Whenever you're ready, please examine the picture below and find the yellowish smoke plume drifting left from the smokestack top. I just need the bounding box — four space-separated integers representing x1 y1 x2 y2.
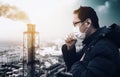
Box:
0 4 30 23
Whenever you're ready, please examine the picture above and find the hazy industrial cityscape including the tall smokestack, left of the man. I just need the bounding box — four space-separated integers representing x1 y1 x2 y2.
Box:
0 24 71 77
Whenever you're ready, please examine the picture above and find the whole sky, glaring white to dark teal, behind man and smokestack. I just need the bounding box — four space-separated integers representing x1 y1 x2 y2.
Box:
0 0 120 40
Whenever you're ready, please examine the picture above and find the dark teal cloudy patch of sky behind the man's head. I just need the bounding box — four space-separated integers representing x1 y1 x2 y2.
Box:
80 0 120 26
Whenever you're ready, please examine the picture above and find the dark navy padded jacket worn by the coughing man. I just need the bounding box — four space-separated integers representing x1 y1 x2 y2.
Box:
62 28 120 77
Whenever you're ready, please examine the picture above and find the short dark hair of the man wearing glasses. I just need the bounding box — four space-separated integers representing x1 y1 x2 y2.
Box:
74 6 99 29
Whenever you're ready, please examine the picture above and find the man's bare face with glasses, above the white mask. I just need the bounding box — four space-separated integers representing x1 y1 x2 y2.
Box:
73 14 87 33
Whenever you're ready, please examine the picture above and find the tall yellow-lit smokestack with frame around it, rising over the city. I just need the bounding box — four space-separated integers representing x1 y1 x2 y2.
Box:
23 24 39 77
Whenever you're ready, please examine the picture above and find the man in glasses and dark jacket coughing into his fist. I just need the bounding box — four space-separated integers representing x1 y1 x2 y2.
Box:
62 6 120 77
